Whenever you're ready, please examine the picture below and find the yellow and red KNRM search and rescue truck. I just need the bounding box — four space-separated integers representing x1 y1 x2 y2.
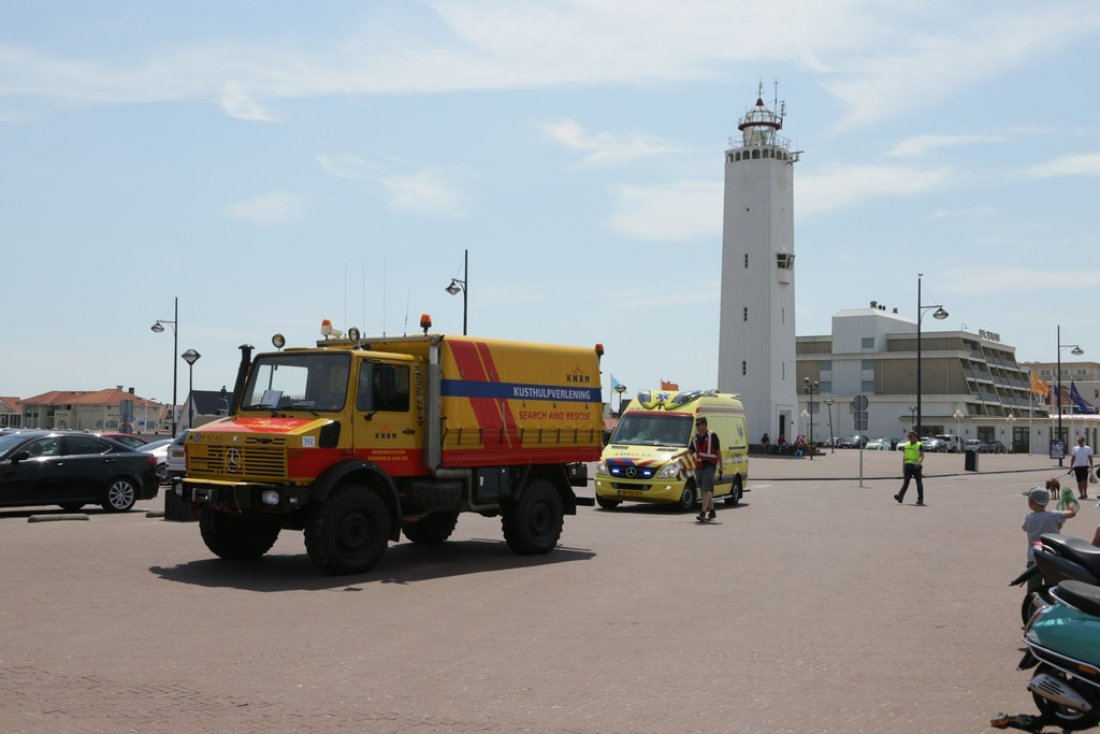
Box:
180 316 603 573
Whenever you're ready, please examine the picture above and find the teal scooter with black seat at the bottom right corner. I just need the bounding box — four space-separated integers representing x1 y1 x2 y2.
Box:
1019 580 1100 732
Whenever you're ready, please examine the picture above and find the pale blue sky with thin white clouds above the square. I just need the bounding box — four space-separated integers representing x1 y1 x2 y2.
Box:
0 0 1100 403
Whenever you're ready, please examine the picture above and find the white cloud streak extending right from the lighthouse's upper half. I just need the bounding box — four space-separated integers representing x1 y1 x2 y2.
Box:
794 166 952 218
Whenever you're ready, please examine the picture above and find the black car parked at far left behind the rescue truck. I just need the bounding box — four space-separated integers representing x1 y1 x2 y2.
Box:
0 430 157 512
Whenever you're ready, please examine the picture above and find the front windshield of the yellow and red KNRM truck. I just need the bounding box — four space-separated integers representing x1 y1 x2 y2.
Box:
241 352 351 410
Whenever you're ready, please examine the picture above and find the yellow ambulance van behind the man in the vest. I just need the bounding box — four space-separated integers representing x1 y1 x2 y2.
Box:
595 390 749 511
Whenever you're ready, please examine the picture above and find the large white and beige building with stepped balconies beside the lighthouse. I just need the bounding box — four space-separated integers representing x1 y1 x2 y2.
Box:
796 302 1100 453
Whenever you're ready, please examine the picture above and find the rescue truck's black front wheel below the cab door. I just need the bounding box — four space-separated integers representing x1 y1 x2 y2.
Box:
306 484 389 573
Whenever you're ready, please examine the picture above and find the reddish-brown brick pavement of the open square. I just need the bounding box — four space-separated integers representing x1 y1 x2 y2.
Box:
0 451 1082 734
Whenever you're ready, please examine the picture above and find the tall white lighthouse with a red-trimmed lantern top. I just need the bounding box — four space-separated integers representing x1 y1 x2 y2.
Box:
718 87 802 445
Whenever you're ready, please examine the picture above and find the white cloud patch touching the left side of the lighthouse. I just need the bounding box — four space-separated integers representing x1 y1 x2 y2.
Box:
612 180 723 241
